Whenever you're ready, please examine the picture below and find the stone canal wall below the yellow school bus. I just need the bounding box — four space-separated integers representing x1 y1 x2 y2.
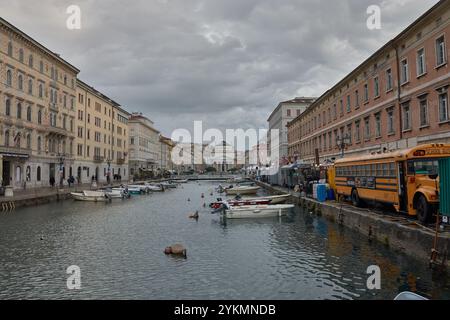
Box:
256 181 450 269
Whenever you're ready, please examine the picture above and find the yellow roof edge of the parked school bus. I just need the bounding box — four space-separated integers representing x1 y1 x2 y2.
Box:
335 144 450 165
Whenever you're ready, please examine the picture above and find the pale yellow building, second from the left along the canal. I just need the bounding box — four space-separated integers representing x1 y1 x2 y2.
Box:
74 80 130 183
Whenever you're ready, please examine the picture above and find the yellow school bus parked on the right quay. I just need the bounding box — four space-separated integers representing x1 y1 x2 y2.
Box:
335 144 450 223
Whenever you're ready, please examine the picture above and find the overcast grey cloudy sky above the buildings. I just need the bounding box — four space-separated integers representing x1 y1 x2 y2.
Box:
0 0 437 136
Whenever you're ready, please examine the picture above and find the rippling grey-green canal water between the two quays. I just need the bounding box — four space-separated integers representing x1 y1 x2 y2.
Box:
0 182 450 299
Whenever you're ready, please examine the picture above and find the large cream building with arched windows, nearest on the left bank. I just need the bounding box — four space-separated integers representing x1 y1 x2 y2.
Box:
0 18 79 188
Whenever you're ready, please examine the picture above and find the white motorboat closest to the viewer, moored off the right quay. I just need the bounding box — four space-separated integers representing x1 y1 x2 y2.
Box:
224 204 294 219
